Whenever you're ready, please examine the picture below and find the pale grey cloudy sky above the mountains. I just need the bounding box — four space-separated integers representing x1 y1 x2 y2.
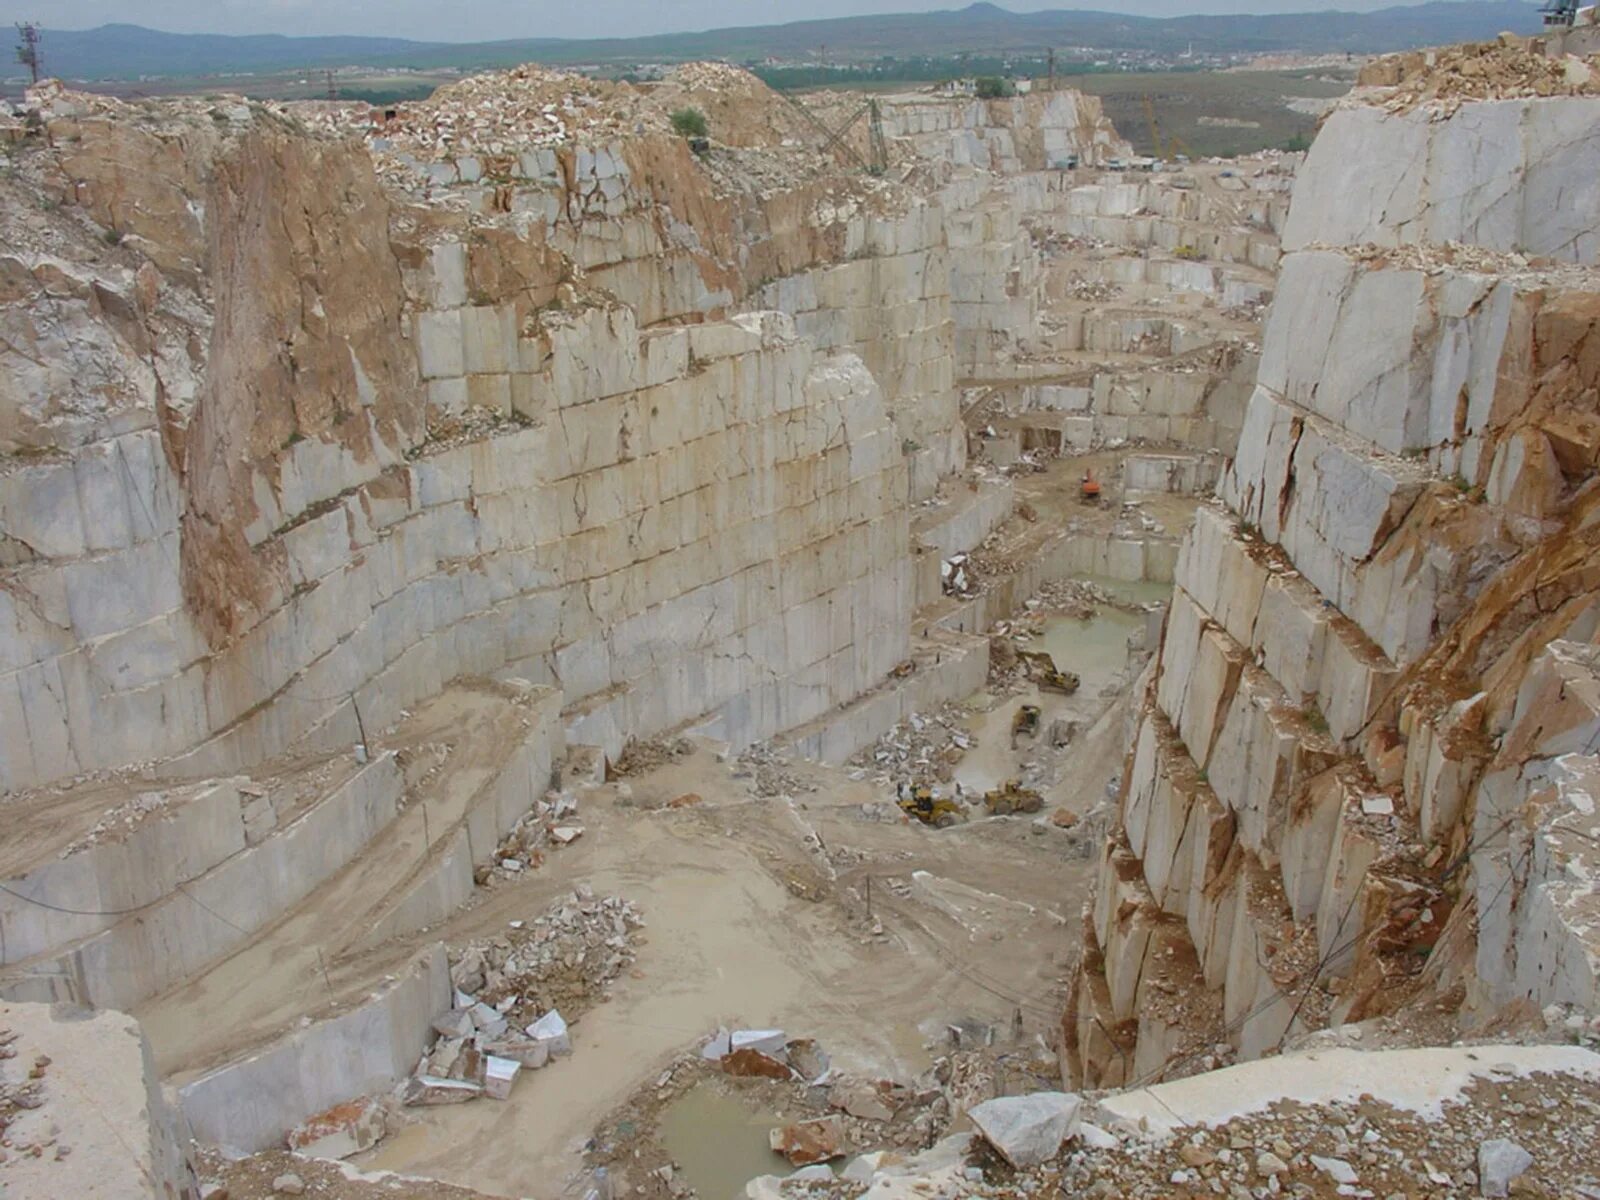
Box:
0 0 1478 42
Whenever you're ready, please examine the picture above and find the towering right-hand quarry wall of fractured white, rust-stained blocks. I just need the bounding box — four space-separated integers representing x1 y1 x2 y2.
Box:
1064 99 1600 1085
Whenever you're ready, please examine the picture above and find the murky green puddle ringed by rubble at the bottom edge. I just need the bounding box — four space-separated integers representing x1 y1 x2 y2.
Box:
661 1083 794 1200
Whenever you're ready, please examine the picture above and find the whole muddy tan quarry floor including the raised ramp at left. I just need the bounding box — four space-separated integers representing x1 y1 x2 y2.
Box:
138 454 1194 1200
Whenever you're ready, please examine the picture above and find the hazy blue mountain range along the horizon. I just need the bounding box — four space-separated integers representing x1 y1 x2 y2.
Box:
12 0 1539 80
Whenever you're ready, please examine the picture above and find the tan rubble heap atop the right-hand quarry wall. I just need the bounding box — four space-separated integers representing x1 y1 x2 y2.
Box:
1357 34 1600 114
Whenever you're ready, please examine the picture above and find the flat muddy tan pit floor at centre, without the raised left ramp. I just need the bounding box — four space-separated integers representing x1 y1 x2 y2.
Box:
342 672 1122 1197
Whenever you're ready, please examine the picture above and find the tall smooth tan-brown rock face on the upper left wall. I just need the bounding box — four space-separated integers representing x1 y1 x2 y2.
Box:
184 130 422 645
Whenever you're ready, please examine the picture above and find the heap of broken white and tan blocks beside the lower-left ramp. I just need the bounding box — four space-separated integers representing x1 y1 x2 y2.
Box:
402 886 643 1104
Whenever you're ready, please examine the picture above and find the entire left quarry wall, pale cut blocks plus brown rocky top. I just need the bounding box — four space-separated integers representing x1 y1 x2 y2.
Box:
0 72 1139 800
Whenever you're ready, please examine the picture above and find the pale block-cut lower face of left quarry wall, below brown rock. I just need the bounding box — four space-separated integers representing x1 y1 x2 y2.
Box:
0 307 910 787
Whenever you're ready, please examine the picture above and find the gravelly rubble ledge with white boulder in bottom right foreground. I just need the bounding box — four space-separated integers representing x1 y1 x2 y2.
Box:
723 1046 1600 1200
